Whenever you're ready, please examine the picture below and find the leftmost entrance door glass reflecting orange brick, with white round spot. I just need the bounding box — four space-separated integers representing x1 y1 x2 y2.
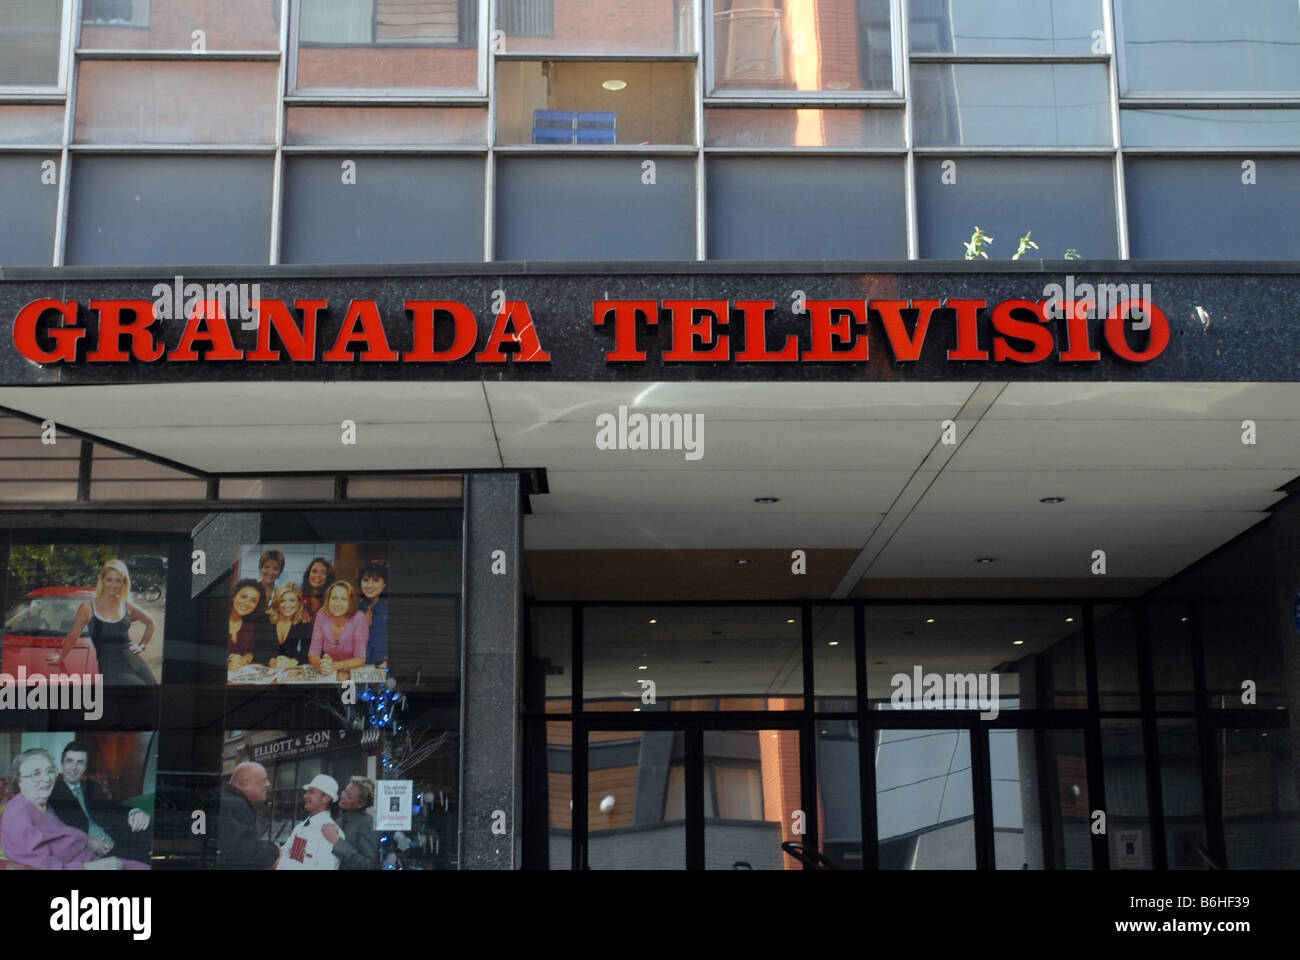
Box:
586 730 686 870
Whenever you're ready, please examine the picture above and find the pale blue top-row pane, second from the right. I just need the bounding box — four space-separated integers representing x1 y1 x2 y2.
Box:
907 0 1104 55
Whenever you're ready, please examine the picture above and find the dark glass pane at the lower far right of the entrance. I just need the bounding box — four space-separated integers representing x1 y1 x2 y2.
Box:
1214 728 1300 870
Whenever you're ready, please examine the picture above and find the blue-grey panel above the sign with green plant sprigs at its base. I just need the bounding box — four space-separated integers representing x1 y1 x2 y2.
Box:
917 156 1118 260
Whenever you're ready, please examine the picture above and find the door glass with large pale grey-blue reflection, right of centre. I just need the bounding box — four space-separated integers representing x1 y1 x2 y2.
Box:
875 730 975 870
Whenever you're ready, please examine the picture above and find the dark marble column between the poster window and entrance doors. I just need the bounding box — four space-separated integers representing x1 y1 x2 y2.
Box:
460 473 524 870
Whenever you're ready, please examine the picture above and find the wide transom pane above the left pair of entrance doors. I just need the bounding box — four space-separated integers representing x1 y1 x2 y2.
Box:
582 606 803 710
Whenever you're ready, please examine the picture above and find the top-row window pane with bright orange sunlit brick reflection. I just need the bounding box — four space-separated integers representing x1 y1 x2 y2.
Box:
710 0 894 96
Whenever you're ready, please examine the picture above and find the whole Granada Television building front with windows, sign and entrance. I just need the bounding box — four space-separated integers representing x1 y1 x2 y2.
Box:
0 0 1300 869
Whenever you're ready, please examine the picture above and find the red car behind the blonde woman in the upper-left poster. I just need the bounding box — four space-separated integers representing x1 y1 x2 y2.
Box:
0 587 99 679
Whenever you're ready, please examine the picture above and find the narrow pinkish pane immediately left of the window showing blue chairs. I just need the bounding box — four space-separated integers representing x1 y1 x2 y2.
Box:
285 107 488 147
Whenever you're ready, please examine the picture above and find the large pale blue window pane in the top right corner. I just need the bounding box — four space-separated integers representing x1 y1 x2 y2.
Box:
1117 0 1300 95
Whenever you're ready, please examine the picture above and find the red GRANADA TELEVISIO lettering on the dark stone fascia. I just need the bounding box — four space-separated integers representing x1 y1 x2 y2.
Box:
13 297 1170 364
